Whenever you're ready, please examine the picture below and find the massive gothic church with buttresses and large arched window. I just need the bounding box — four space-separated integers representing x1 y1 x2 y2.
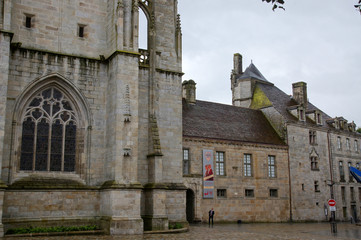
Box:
0 0 186 234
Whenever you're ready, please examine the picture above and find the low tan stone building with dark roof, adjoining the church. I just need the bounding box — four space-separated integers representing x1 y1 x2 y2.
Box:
183 80 290 222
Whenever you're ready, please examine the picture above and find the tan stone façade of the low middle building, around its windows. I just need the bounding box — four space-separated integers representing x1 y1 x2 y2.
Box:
183 138 290 222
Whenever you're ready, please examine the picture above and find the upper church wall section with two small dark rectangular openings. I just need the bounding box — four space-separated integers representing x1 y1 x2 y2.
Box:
11 0 107 58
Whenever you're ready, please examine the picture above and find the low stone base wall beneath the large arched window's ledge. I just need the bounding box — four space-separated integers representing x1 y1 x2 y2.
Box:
3 190 100 229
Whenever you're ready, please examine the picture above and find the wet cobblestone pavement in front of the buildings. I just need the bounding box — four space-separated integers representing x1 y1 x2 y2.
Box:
3 223 361 240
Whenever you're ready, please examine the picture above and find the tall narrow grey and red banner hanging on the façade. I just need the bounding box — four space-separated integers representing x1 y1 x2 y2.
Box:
203 150 214 198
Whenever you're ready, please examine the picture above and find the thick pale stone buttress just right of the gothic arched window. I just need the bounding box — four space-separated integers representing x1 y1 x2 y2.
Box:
101 51 143 235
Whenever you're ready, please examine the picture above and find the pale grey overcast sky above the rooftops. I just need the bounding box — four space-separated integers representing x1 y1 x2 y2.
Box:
178 0 361 127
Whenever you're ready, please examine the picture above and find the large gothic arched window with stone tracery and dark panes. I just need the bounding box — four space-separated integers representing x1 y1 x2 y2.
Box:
20 87 77 172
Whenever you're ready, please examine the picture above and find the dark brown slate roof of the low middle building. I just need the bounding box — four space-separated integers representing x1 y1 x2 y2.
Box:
183 100 285 145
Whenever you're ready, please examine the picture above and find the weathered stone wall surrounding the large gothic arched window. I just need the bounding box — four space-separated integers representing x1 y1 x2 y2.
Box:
2 49 107 184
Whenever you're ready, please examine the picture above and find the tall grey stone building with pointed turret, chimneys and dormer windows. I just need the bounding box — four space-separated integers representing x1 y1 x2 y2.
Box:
231 54 361 221
